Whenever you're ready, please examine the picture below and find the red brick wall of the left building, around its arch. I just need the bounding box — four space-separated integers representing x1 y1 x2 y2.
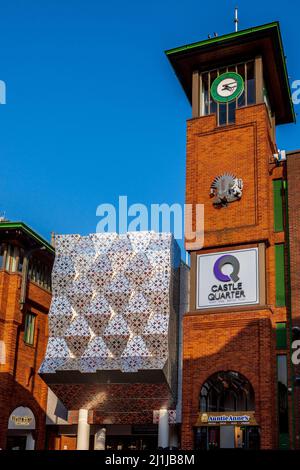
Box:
0 271 51 449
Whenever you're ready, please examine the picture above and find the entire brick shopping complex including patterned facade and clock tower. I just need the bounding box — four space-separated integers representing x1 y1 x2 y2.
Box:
8 19 300 450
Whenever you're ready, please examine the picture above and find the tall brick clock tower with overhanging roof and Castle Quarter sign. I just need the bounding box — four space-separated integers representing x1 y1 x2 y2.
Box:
166 23 295 449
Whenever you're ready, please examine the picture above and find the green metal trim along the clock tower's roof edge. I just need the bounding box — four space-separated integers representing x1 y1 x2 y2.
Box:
165 21 296 122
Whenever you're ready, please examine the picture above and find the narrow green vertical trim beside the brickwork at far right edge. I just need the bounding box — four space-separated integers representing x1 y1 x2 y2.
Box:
283 180 296 449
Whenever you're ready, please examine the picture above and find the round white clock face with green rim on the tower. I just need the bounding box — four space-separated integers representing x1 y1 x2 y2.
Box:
210 72 244 103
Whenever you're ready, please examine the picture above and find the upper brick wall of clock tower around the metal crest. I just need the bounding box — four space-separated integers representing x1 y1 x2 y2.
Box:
186 105 276 247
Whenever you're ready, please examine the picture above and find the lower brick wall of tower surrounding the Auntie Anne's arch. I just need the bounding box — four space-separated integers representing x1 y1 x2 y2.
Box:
182 310 276 449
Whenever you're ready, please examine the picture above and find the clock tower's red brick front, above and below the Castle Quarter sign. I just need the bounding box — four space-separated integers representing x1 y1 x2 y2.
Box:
182 104 287 449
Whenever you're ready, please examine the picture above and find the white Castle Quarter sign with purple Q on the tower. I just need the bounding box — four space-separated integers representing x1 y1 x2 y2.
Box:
197 248 259 309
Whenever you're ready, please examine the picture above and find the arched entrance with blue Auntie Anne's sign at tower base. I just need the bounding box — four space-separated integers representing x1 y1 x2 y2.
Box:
195 371 260 449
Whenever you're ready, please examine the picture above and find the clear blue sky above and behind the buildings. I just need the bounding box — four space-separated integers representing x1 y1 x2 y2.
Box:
0 0 300 253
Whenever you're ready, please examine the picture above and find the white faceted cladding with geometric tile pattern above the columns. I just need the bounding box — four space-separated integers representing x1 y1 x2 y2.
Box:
40 232 180 373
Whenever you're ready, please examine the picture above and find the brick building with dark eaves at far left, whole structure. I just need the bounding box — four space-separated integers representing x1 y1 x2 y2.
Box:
0 221 54 449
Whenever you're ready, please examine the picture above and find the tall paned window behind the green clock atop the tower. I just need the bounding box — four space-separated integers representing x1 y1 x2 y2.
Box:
200 60 256 126
